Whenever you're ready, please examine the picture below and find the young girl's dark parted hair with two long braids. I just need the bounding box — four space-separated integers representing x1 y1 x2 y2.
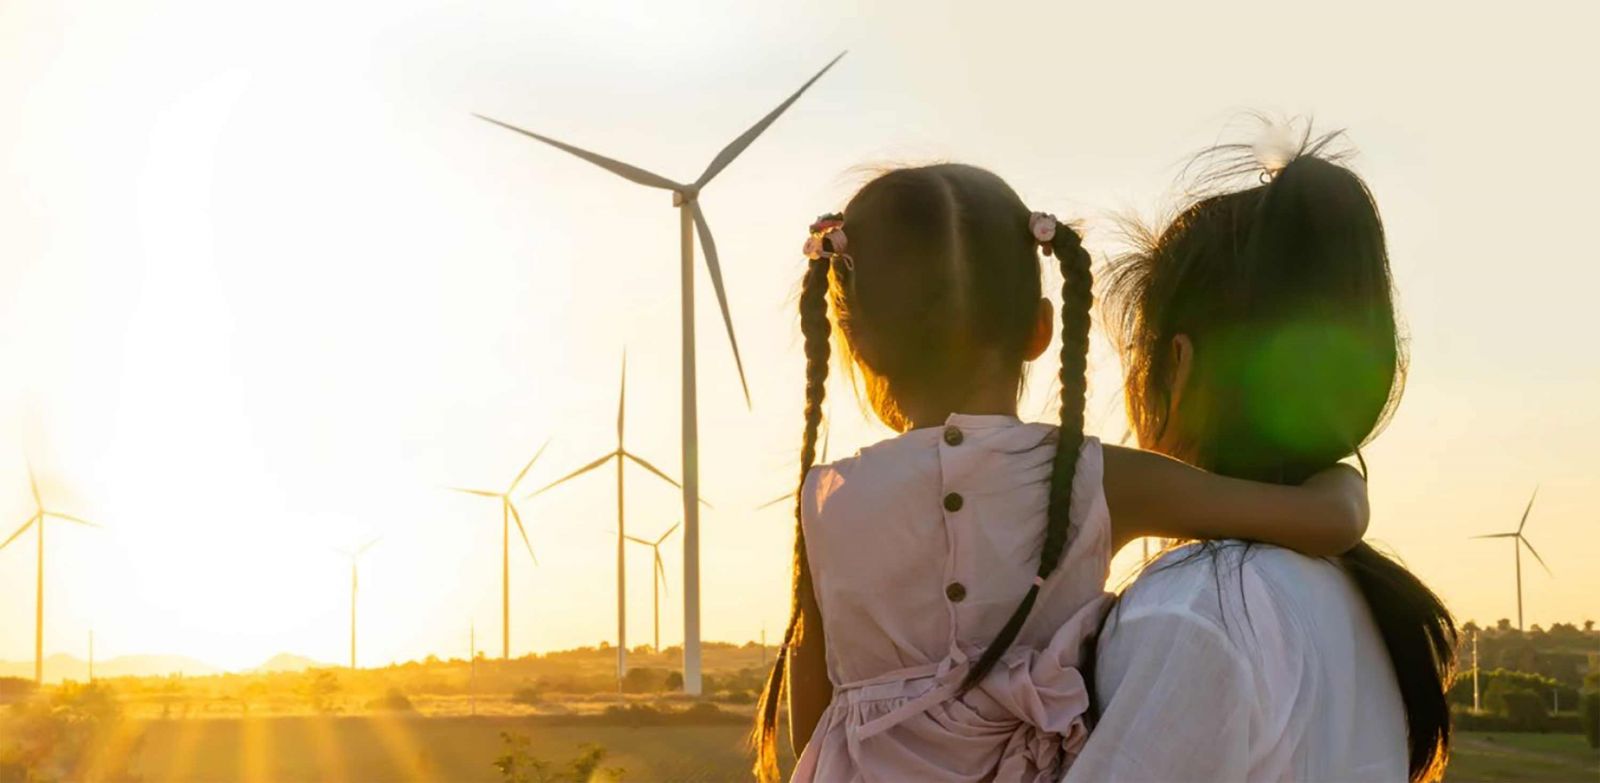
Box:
752 163 1094 781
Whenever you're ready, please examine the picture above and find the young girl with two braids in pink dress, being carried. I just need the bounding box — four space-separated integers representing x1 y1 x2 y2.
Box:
754 165 1366 781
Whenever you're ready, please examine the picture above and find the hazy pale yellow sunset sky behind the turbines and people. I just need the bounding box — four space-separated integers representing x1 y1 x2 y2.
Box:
0 0 1600 666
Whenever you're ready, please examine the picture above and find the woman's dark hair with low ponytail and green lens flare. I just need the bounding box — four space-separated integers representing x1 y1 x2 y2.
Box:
1106 133 1456 781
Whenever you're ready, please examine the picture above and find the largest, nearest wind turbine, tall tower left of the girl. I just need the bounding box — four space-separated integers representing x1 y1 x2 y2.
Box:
474 53 845 693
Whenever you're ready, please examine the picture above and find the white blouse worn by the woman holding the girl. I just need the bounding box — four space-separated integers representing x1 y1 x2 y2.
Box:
1066 541 1406 783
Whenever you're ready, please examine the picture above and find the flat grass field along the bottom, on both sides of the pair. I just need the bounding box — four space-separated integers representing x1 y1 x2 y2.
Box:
31 714 1600 783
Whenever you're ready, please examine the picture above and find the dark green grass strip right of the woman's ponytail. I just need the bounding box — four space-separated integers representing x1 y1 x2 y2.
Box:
1445 732 1600 783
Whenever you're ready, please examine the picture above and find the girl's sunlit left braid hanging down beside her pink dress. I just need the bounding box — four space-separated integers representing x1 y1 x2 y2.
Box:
750 255 832 783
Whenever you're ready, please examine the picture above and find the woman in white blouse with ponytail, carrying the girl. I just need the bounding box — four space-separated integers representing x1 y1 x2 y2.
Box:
1067 138 1456 781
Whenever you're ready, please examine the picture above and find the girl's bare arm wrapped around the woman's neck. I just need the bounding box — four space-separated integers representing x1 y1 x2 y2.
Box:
1102 445 1370 557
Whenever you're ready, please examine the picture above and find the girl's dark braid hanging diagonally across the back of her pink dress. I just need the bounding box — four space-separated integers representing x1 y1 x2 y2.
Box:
962 224 1094 693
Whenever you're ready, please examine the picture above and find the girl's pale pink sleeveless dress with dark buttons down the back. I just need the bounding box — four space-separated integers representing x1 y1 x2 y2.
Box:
794 415 1112 783
